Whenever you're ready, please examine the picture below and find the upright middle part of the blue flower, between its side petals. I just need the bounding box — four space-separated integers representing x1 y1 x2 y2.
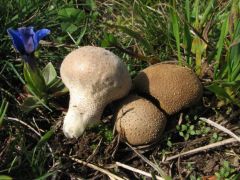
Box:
18 27 36 54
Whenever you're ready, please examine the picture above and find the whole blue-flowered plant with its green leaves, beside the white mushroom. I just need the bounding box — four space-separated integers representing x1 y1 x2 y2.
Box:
7 27 67 112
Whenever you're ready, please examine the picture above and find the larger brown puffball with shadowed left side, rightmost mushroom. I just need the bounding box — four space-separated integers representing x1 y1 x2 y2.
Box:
133 64 203 115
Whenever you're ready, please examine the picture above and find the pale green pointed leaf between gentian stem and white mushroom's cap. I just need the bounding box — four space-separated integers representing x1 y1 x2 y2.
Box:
42 62 57 86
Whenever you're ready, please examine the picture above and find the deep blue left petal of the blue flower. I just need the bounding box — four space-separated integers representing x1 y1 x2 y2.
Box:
7 28 26 54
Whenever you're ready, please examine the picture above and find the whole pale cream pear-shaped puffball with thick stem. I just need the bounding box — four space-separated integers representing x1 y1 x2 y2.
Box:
60 46 132 138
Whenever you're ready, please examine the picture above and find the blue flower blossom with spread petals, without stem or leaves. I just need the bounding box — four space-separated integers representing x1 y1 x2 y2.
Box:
7 27 50 56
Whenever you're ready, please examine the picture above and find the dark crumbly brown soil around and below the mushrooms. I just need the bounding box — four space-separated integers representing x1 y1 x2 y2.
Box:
0 86 240 180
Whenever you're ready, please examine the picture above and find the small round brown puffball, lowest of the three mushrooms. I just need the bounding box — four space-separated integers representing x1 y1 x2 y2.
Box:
115 95 166 145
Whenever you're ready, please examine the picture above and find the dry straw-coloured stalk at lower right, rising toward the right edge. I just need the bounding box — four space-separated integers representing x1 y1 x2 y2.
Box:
166 138 237 161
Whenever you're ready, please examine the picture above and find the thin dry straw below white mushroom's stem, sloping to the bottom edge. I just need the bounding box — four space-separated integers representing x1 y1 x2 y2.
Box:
68 156 124 180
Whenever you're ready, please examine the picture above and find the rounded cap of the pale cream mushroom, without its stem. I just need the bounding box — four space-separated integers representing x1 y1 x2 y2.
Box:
60 46 132 103
